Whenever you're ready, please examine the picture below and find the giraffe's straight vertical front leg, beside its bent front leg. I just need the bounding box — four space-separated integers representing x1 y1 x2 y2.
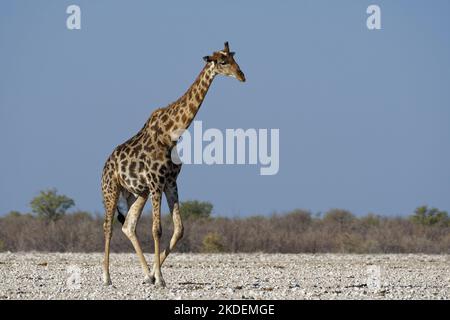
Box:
150 192 166 287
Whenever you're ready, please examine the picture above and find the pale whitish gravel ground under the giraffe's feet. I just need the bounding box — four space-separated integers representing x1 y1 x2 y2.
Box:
0 253 450 299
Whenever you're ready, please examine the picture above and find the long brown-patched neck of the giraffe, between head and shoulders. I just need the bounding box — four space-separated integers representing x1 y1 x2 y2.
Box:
167 63 215 130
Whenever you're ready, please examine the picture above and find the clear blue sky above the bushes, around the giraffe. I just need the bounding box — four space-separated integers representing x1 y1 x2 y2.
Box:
0 0 450 216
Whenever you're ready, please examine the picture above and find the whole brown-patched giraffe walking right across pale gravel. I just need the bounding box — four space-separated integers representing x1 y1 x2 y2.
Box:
101 42 245 287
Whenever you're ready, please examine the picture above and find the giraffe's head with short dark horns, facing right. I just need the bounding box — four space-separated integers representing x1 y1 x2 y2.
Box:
203 42 245 82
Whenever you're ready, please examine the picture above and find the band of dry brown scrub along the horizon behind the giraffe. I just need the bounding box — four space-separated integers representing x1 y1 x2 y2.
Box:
0 202 450 254
